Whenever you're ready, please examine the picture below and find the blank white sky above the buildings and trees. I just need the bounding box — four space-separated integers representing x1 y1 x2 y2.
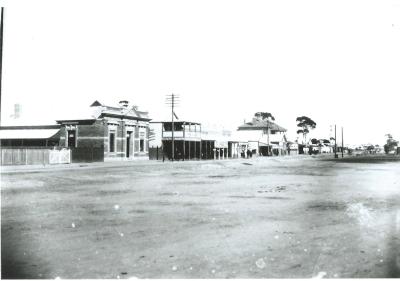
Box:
0 0 400 145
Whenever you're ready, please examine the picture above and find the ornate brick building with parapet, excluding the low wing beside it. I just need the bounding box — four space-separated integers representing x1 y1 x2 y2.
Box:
57 101 151 161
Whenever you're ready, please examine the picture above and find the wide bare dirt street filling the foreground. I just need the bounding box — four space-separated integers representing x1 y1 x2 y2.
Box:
1 156 400 278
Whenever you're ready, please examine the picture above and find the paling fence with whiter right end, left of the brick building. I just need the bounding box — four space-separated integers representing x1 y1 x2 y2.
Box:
0 147 71 166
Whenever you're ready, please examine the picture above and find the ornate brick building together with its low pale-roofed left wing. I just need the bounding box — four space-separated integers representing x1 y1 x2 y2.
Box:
0 101 151 162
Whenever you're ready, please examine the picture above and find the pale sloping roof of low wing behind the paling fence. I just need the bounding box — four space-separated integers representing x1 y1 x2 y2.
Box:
0 126 60 139
